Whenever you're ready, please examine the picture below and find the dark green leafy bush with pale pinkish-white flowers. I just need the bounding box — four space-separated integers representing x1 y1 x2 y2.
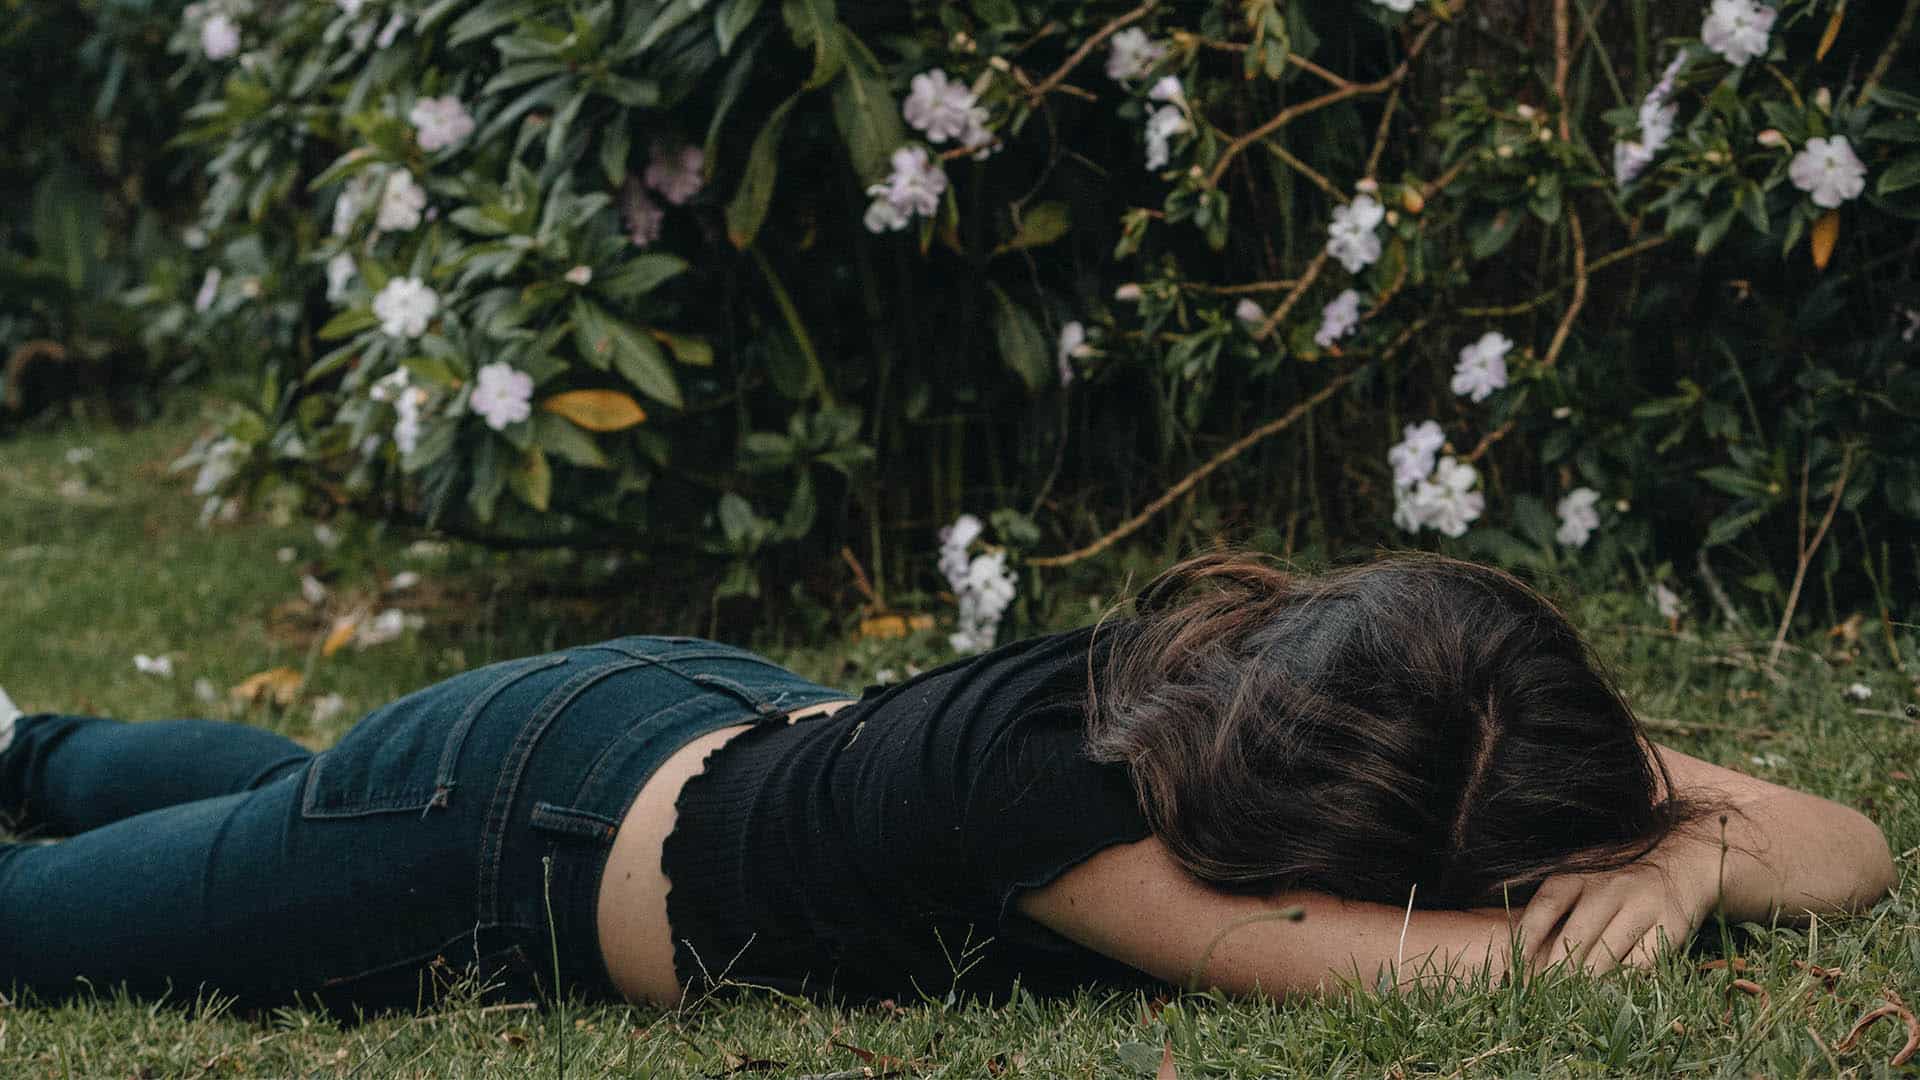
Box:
108 0 1920 622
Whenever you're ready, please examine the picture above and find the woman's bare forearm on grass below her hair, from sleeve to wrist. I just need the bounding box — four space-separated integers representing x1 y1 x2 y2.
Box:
1018 838 1519 995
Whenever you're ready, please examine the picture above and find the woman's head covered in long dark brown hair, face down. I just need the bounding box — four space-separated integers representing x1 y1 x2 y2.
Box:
1089 555 1697 907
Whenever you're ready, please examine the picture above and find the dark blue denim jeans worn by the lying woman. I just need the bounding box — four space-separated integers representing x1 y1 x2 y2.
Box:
0 638 847 1013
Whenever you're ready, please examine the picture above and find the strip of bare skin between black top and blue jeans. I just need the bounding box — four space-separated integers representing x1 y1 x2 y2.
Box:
597 700 852 1005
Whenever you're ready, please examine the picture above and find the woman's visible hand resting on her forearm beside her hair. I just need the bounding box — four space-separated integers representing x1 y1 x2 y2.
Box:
1519 836 1720 974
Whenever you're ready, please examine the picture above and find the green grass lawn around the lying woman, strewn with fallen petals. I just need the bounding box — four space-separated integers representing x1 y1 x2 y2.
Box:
0 402 1920 1078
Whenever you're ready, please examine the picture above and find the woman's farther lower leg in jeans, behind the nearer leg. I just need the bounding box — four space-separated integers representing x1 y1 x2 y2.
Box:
0 713 313 836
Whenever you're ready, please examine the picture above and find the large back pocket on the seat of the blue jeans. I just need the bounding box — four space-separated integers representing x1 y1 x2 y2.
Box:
300 653 566 819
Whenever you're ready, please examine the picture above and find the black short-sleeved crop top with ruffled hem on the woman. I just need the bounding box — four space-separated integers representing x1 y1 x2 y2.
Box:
660 623 1152 999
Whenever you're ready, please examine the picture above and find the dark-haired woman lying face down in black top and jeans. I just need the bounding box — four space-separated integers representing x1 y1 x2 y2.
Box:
0 555 1893 1009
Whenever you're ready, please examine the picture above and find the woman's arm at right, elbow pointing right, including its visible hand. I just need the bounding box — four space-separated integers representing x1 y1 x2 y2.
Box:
1521 744 1895 970
